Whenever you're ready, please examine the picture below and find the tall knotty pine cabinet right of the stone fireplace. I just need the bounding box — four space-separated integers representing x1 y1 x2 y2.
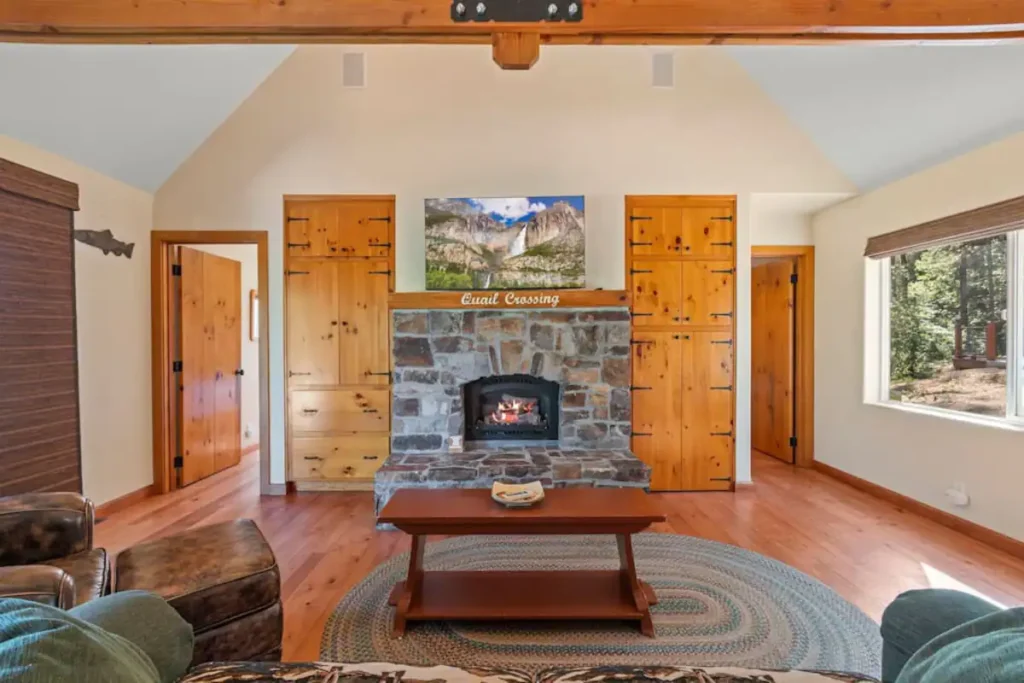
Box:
626 197 736 490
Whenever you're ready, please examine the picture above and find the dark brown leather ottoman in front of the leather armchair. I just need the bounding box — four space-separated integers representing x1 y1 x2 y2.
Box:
114 519 283 666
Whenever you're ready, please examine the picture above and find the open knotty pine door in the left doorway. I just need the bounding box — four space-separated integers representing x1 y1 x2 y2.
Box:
177 247 242 485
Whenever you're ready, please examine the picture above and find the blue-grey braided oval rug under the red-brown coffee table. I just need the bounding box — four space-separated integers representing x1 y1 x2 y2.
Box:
321 533 882 677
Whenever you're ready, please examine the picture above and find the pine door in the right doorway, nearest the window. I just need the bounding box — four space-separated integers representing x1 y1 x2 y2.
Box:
751 259 796 463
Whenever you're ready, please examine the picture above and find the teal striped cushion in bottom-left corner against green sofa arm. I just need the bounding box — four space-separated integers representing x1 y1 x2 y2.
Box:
0 599 161 683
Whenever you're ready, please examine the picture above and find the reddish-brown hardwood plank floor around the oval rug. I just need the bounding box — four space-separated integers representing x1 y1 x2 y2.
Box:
96 454 1024 660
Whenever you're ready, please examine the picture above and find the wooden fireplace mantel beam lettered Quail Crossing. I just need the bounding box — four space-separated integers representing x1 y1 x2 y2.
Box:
388 290 630 309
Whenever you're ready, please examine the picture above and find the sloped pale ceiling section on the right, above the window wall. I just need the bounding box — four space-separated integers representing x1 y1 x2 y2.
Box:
727 44 1024 189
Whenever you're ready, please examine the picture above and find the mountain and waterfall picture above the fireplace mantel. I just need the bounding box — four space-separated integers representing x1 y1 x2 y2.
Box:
425 197 584 290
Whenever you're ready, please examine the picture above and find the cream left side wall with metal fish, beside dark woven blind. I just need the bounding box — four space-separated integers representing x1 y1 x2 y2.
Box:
0 135 153 505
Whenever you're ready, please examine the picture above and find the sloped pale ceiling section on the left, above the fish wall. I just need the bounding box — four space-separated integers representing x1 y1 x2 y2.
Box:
0 44 294 191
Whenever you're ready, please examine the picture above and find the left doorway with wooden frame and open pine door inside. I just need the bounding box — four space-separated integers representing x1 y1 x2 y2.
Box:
153 231 278 493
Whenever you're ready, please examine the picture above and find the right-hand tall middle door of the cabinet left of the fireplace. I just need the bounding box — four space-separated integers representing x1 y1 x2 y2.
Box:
338 259 391 385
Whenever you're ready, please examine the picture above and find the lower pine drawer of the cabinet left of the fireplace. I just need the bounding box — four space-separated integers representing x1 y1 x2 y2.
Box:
292 434 391 480
